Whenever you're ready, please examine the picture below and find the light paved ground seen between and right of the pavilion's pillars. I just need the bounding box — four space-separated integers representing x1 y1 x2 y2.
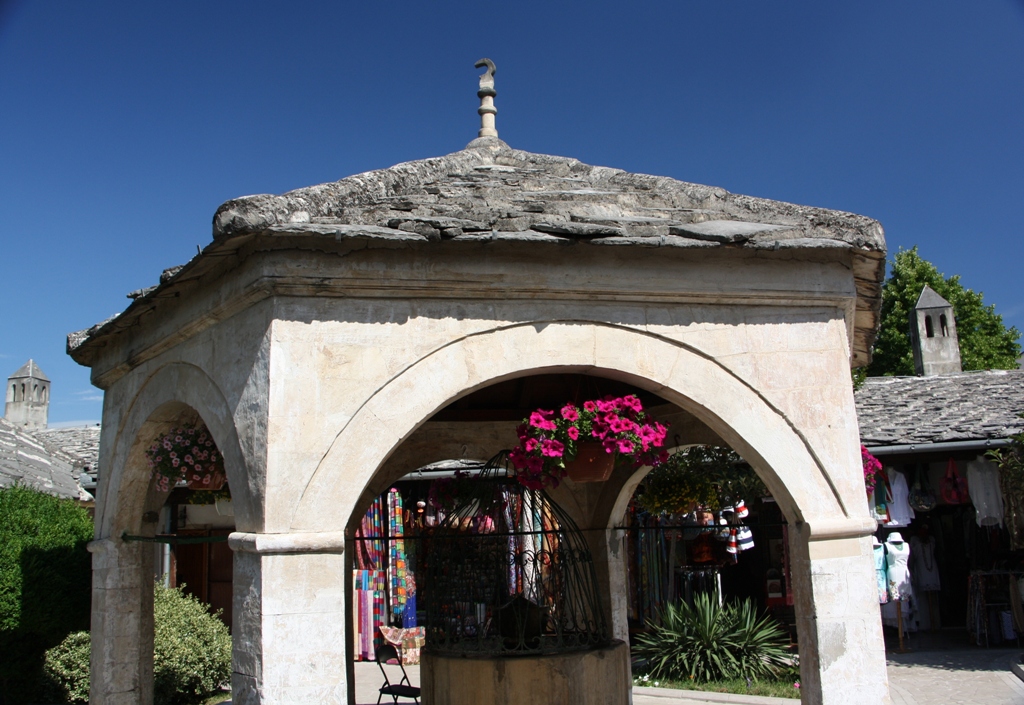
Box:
335 649 1024 705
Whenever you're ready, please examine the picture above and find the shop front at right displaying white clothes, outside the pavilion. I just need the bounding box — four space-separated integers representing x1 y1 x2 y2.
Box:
870 451 1024 649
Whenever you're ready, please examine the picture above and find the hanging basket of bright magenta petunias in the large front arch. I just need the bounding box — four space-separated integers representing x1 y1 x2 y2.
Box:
509 395 668 490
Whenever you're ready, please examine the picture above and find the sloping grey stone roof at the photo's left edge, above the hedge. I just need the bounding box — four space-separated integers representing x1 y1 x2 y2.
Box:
0 418 88 499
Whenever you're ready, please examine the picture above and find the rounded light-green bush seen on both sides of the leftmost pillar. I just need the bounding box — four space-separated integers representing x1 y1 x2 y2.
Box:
46 585 231 705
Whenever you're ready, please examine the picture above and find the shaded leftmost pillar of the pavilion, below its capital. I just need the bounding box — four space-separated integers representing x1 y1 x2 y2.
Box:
89 539 153 705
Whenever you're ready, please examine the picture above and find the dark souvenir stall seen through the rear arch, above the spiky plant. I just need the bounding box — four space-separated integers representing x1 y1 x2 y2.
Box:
623 447 796 642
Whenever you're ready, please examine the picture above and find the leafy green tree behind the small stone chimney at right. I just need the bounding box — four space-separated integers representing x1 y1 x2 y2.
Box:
867 246 1021 377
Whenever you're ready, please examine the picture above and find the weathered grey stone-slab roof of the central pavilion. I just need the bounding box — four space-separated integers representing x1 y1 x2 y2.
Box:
68 137 885 364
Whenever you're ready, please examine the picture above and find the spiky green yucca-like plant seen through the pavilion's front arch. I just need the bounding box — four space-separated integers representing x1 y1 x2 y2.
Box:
635 594 791 682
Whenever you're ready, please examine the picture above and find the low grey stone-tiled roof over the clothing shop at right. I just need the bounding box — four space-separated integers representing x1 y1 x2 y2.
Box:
855 370 1024 446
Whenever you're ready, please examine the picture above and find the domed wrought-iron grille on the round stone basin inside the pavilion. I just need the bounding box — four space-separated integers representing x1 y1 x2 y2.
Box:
422 453 610 656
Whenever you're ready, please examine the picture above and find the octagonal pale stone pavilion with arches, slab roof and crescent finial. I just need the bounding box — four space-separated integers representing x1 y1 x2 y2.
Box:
69 60 889 705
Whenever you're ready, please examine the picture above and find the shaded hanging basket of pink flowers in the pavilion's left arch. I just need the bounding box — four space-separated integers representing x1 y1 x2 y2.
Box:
145 425 227 492
